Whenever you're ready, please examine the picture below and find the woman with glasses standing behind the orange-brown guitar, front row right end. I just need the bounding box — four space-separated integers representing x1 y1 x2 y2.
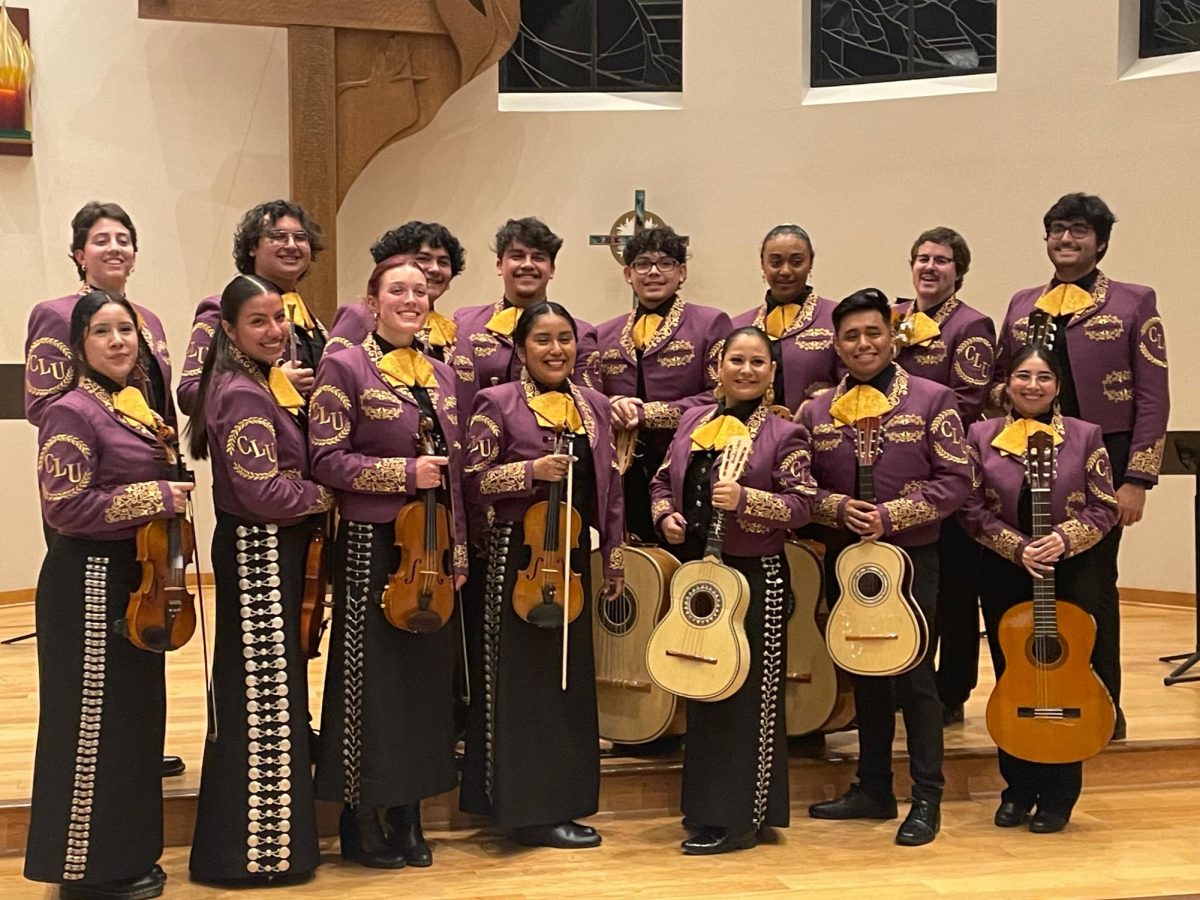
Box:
959 346 1117 834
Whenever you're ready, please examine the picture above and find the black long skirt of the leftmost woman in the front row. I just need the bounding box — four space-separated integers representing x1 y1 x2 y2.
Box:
25 535 167 884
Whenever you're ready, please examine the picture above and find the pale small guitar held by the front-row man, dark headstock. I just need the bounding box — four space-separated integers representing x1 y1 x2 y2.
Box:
826 418 929 676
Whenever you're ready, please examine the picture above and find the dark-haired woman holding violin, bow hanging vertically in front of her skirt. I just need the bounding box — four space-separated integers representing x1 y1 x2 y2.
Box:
461 301 625 848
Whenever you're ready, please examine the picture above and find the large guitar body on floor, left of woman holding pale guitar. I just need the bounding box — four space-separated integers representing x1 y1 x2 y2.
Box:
592 544 683 744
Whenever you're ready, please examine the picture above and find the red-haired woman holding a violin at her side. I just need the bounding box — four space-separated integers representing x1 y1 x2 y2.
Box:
308 258 467 869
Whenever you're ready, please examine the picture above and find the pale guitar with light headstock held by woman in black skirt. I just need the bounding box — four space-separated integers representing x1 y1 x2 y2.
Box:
646 437 752 701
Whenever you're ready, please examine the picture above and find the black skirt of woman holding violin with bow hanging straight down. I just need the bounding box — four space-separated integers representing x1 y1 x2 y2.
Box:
461 522 600 828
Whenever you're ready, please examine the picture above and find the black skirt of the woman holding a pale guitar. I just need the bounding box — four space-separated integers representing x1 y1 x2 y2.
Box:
680 556 790 834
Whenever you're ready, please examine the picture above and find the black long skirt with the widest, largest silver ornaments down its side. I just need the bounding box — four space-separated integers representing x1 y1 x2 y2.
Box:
188 514 320 881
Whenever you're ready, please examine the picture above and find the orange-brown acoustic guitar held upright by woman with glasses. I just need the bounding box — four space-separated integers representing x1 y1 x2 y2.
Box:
988 433 1116 762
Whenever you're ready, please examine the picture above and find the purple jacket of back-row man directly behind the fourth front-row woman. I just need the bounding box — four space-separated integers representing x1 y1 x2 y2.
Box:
446 300 600 409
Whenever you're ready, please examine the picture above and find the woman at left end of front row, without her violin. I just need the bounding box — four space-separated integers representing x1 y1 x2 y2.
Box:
25 290 193 898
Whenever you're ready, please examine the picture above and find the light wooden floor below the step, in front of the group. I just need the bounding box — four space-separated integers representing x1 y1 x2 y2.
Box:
0 790 1200 900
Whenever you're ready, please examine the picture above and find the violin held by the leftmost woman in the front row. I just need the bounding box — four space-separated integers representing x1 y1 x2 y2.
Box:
116 443 196 653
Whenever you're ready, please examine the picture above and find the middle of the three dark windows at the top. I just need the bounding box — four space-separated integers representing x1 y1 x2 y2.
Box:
811 0 996 88
